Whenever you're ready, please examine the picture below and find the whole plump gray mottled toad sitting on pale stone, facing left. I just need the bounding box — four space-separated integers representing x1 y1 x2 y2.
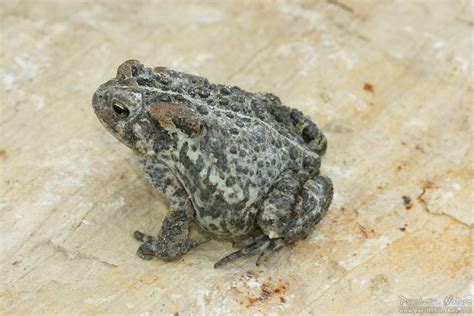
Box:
92 60 333 267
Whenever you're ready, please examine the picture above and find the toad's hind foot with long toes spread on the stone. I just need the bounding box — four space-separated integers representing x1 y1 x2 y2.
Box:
214 234 287 268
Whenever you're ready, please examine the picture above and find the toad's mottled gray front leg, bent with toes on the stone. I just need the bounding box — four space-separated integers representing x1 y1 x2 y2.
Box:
134 161 204 261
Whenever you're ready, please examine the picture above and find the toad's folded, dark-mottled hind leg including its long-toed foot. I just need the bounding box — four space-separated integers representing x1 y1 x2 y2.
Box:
215 172 333 268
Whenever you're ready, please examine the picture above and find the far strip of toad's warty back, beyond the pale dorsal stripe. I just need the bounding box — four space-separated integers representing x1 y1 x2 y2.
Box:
130 67 327 155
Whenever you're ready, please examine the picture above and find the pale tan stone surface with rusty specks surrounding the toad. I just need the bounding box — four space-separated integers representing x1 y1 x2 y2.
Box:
0 0 474 314
